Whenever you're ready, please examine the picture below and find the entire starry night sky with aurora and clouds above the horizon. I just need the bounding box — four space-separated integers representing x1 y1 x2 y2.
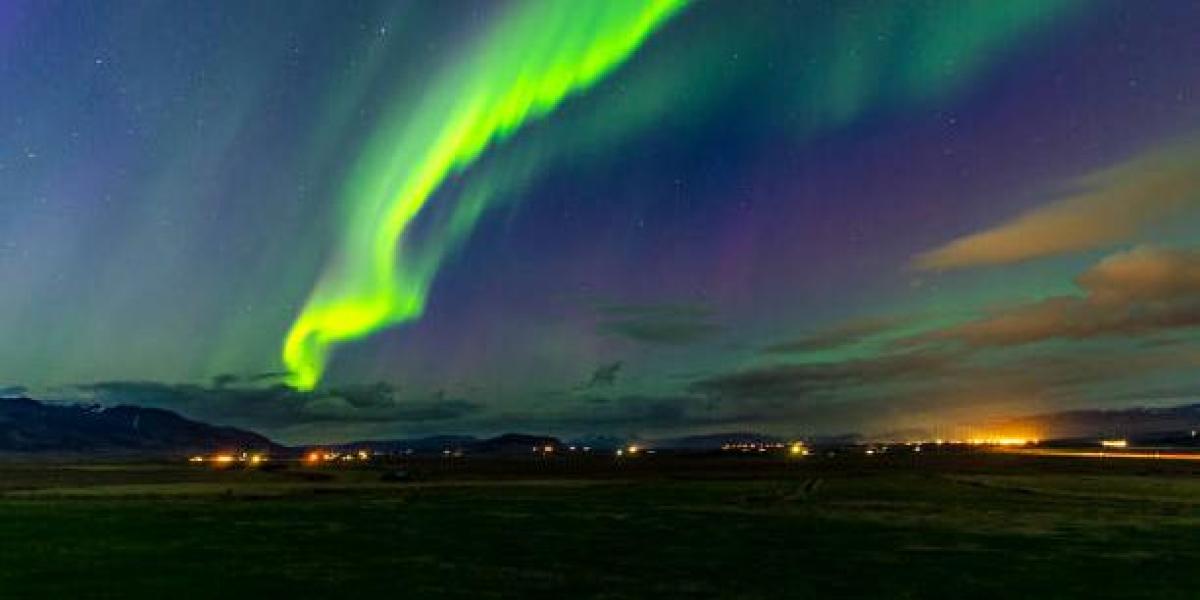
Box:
0 0 1200 442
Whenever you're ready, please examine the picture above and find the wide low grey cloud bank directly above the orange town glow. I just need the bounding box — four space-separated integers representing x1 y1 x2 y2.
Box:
688 346 1200 433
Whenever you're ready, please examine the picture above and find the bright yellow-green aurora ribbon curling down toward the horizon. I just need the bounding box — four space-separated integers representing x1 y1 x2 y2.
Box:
283 0 685 390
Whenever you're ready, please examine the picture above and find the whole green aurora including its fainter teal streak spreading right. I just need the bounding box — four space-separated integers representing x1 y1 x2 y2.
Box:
283 0 1080 390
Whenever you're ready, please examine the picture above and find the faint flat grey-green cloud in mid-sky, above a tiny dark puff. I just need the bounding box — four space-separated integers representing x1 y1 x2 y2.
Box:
596 305 721 346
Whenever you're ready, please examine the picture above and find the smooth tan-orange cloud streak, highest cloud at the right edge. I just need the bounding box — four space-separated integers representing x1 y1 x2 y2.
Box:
913 140 1200 270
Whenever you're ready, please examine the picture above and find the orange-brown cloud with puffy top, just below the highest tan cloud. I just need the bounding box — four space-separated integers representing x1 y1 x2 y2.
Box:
905 246 1200 347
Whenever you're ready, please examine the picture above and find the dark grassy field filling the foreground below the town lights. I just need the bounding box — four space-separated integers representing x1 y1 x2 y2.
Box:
0 455 1200 599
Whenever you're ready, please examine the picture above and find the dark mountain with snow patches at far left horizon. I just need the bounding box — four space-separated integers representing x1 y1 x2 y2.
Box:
0 397 274 454
